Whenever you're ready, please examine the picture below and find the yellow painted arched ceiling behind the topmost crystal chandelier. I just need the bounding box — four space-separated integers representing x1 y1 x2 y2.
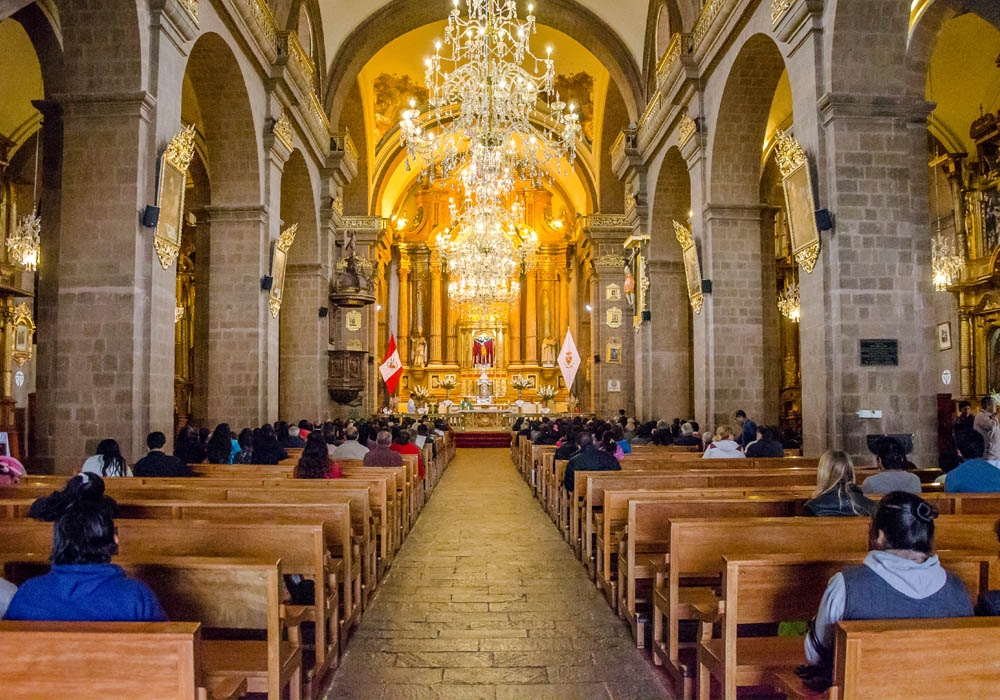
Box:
358 21 610 218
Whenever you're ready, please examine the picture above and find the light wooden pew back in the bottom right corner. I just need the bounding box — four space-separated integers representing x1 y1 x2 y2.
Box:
830 617 1000 700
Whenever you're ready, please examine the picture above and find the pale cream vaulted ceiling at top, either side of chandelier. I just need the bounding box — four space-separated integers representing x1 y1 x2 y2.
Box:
319 0 649 75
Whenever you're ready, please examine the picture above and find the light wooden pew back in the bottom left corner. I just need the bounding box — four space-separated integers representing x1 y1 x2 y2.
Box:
0 621 246 700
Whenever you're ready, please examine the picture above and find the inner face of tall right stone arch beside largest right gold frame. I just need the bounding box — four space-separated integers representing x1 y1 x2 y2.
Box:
695 34 785 423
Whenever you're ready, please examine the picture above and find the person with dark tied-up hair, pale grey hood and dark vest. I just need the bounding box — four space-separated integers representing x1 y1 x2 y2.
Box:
796 491 972 690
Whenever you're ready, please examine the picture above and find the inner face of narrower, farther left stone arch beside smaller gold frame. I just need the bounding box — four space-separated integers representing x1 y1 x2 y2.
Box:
278 150 324 423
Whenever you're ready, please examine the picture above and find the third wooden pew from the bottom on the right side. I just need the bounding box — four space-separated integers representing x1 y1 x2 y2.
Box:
653 515 997 697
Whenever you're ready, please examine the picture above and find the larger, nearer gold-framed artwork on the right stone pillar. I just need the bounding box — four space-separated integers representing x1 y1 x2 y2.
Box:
775 129 820 274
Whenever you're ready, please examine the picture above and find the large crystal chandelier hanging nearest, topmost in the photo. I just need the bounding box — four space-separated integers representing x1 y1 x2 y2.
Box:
400 0 580 192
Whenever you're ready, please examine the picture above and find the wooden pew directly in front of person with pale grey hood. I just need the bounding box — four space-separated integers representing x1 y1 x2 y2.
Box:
698 552 996 700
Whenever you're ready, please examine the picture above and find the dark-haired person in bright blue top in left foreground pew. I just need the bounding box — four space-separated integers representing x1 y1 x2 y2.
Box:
4 490 167 622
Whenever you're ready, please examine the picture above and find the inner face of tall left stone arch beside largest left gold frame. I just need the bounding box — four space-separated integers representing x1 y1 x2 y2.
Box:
181 33 270 425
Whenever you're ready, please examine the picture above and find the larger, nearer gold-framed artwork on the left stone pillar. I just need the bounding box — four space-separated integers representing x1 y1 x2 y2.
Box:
153 124 195 270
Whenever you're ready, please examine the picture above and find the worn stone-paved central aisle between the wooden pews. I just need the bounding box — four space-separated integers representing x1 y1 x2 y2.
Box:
327 449 669 700
